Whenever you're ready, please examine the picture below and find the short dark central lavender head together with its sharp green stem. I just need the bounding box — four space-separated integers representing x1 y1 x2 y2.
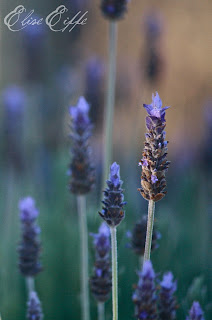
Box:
99 162 126 320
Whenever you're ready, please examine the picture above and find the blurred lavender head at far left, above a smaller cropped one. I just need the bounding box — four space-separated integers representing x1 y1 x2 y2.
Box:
18 197 42 277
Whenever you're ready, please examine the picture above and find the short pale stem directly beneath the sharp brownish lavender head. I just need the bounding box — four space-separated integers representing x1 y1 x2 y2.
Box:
143 200 155 262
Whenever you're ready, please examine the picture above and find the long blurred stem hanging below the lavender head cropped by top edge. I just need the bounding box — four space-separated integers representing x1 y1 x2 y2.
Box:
102 21 117 188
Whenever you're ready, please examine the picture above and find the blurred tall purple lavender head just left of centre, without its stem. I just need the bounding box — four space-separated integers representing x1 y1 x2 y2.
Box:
69 97 95 194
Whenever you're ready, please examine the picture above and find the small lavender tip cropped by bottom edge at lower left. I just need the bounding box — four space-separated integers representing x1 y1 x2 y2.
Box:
27 291 43 320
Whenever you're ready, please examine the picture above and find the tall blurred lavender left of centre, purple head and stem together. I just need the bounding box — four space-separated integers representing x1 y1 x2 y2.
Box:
69 97 95 320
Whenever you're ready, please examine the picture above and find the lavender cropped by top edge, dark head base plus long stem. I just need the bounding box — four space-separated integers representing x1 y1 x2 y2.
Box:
101 0 128 188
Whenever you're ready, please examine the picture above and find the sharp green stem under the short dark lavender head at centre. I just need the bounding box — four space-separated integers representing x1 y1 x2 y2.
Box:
110 227 118 320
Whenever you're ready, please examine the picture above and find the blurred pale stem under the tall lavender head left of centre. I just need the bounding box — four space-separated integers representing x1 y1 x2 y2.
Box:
77 195 90 320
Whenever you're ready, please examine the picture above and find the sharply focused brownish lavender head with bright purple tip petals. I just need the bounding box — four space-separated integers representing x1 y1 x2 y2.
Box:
138 92 170 201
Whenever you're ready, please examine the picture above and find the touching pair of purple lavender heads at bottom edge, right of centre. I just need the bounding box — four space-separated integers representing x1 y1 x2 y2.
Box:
132 261 177 320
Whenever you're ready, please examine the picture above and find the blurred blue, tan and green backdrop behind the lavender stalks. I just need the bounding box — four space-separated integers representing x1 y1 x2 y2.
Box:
0 0 212 320
